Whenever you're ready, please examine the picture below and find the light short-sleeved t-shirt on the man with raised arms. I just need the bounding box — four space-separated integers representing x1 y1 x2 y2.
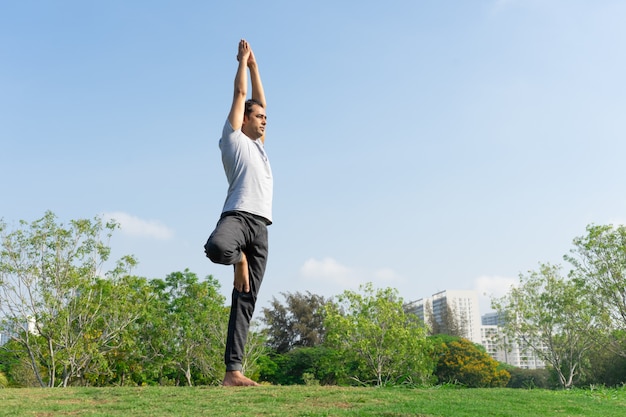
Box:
220 119 274 224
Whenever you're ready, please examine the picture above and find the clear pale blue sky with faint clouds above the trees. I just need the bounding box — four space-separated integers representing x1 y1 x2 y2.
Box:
0 0 626 312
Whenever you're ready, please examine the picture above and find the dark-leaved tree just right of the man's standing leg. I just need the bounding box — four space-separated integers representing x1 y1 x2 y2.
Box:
262 291 329 353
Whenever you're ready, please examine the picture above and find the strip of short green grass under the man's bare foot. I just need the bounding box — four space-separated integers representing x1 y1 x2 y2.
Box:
0 386 626 417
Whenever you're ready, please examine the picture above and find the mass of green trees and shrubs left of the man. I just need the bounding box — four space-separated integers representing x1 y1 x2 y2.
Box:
0 212 239 387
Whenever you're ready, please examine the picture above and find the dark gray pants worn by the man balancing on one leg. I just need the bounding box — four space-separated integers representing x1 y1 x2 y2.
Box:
204 211 268 371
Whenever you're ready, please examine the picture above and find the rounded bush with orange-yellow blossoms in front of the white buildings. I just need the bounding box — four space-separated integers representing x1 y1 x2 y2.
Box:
433 337 511 388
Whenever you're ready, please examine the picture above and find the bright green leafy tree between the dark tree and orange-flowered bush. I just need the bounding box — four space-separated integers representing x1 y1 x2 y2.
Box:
324 283 433 386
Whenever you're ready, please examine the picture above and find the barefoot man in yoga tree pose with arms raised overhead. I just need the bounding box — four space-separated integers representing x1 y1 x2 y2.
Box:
204 39 273 386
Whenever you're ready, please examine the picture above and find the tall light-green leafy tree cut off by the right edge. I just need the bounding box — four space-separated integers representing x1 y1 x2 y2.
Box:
565 225 626 357
